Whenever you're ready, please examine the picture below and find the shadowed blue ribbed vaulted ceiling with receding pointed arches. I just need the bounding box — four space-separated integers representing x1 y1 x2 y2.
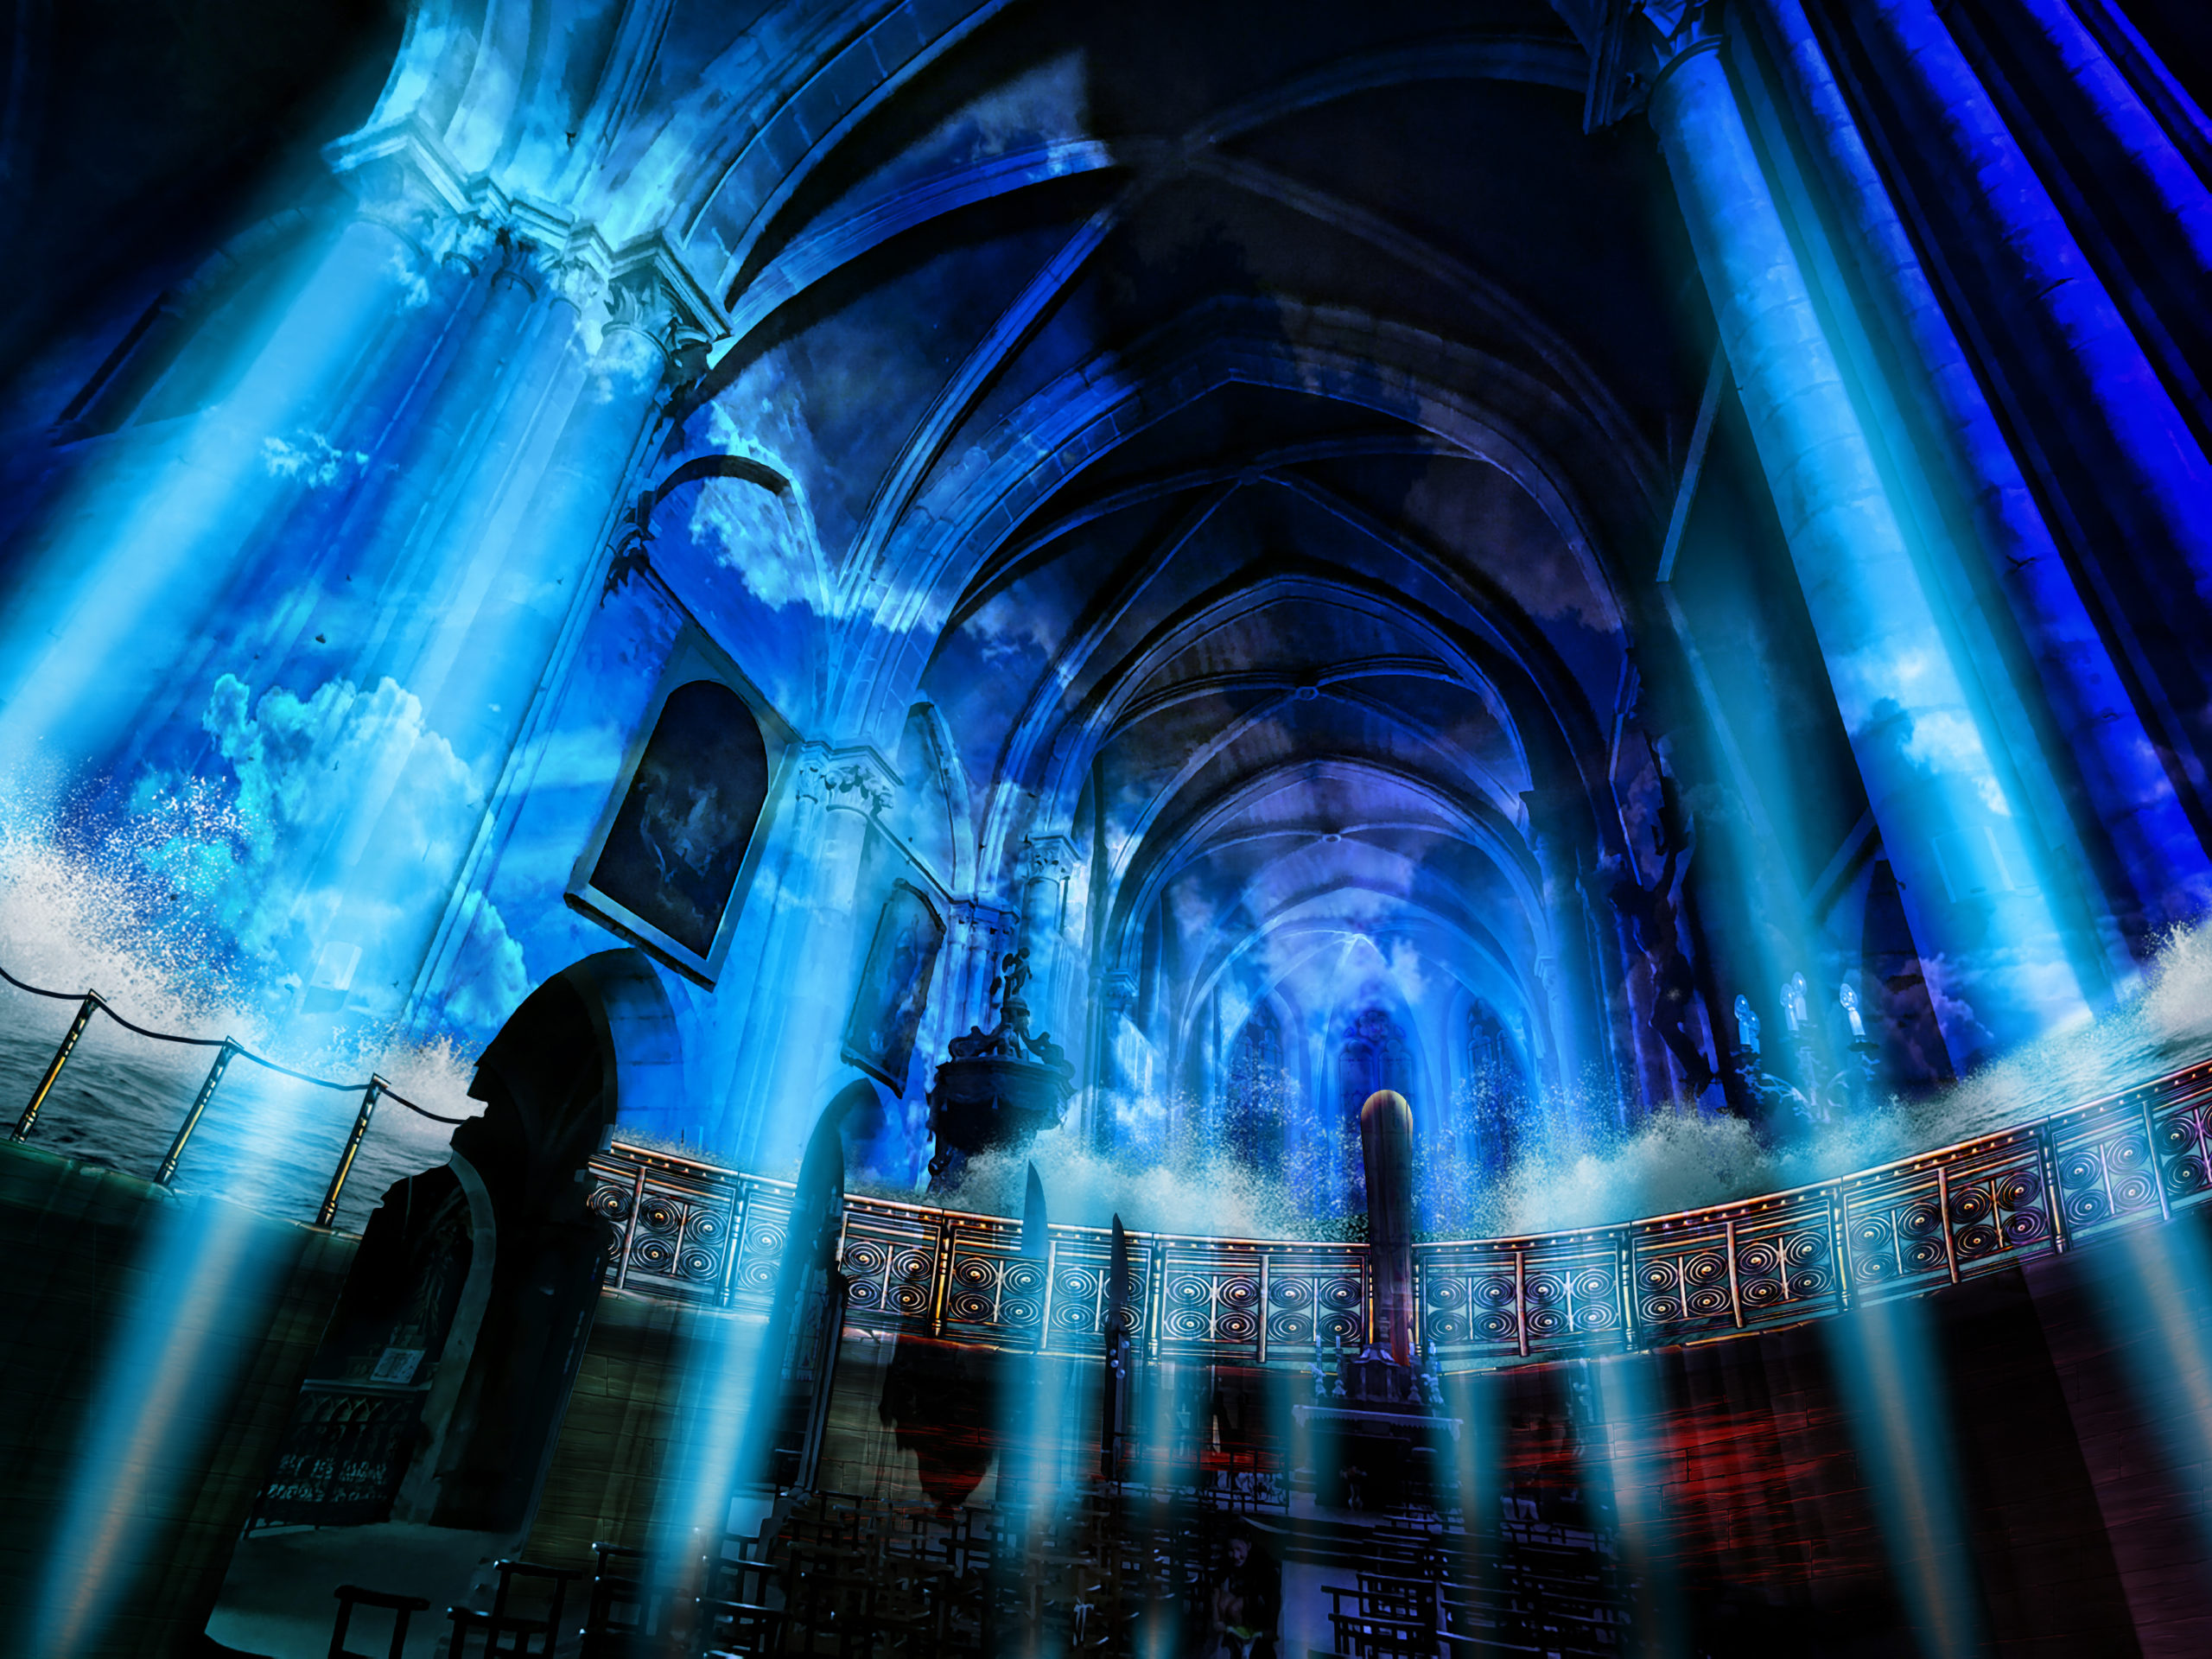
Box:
632 3 1710 1106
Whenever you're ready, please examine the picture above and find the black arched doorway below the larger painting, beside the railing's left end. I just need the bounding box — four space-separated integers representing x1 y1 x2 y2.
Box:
257 949 677 1537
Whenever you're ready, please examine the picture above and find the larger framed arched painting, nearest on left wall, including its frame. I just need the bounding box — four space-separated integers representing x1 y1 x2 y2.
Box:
569 628 790 991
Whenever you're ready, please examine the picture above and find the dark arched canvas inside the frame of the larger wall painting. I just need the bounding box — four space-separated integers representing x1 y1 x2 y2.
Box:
591 679 767 957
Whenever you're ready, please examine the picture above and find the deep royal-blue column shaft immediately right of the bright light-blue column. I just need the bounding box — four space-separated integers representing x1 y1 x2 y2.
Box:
1761 0 2212 943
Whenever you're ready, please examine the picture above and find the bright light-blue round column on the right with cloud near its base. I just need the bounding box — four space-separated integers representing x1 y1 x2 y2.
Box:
1650 0 2086 1059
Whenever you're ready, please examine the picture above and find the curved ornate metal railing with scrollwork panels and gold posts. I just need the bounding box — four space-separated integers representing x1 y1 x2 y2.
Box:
588 1062 2212 1370
